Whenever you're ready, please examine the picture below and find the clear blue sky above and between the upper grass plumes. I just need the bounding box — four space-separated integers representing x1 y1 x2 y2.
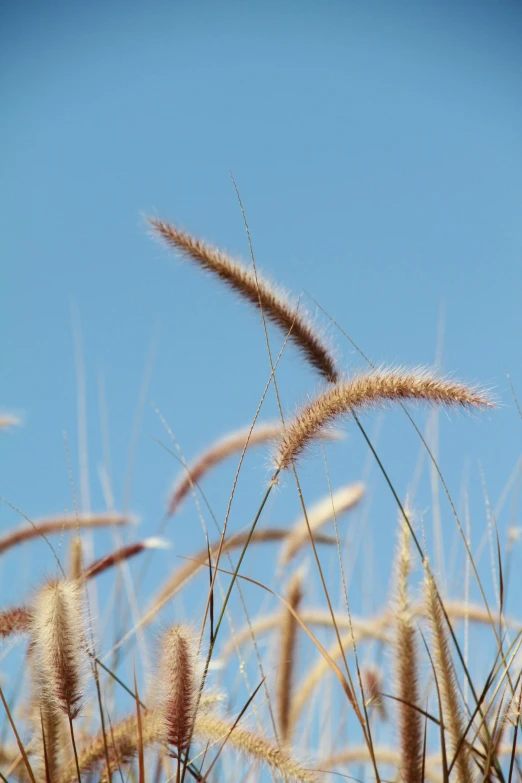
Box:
0 0 522 716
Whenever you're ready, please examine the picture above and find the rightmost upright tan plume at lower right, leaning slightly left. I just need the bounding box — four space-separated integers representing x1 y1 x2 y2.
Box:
424 569 474 783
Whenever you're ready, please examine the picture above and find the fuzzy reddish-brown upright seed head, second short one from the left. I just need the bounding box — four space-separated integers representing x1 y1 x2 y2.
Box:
157 625 200 751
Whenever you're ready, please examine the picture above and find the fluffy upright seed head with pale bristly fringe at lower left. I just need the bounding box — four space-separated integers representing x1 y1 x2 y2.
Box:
31 580 85 719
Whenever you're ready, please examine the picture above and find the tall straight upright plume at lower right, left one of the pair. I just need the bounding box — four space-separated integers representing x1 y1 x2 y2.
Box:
394 511 424 783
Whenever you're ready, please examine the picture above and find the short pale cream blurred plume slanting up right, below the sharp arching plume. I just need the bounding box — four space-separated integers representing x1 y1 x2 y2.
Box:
281 483 364 565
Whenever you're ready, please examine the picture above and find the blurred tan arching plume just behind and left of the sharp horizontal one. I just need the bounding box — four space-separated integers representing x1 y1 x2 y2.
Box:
167 423 282 516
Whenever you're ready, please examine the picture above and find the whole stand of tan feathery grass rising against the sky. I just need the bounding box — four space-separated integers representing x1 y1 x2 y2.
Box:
0 219 522 783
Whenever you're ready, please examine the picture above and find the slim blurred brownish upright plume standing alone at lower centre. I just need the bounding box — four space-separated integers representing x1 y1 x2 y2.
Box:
277 571 303 745
